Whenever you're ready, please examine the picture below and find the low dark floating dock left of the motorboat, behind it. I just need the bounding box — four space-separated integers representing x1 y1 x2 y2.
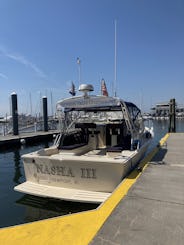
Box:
0 130 59 150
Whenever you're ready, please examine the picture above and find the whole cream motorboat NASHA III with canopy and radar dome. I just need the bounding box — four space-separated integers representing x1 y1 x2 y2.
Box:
15 84 152 203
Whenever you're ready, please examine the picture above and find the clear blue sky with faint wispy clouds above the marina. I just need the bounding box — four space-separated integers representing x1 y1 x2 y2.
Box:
0 0 184 116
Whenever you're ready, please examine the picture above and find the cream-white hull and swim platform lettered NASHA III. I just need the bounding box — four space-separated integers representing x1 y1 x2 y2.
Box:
15 143 148 203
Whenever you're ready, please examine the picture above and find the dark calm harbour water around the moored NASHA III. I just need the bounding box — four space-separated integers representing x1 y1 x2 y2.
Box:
0 120 184 227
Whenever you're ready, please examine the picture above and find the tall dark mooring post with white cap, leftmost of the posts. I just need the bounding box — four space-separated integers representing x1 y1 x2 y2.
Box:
11 92 19 135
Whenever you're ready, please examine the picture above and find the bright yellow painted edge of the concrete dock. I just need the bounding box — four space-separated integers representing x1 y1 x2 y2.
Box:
0 134 169 245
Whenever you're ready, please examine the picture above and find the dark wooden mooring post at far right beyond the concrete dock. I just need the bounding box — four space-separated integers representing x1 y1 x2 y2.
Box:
169 99 176 133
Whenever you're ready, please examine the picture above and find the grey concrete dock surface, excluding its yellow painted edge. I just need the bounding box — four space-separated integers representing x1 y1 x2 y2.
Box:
90 133 184 245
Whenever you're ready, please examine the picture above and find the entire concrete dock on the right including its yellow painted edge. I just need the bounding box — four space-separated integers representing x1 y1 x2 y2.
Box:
0 133 184 245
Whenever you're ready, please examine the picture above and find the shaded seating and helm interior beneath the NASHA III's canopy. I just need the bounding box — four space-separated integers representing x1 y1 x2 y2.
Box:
58 117 131 155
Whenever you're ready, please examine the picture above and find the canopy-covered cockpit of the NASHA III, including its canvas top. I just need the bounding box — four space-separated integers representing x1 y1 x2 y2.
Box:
55 91 143 156
